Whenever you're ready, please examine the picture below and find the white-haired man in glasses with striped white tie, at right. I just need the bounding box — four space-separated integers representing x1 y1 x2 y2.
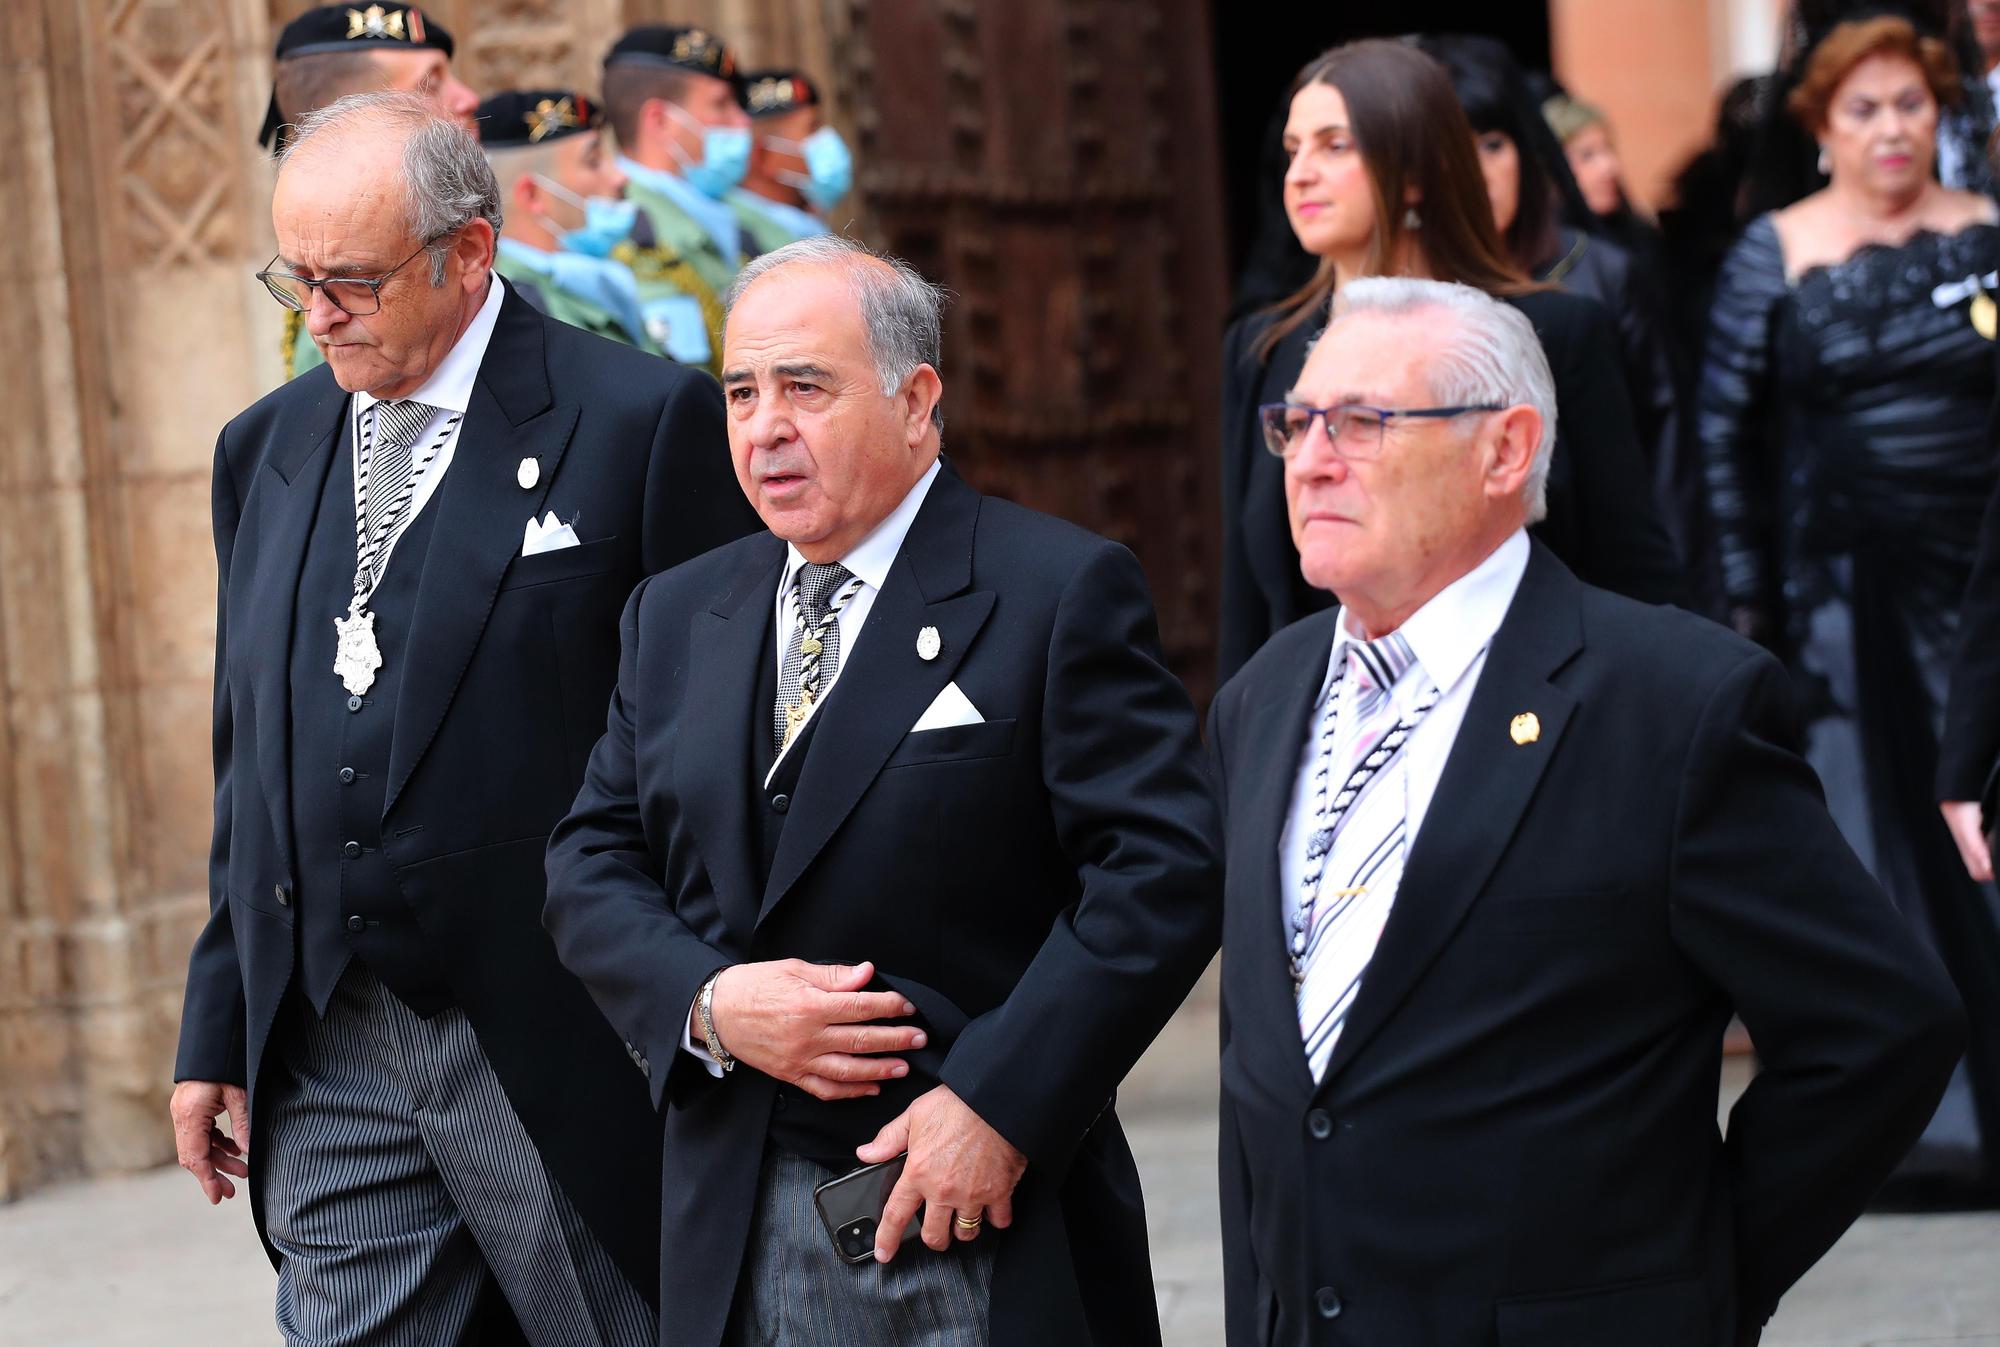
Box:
1210 278 1962 1347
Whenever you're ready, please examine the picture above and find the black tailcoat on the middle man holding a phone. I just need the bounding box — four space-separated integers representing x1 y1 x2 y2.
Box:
548 468 1220 1347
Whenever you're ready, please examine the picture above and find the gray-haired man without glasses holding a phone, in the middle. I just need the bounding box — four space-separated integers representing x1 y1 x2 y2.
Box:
546 236 1220 1347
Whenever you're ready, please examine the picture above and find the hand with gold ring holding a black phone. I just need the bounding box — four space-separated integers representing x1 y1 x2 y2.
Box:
854 1085 1028 1263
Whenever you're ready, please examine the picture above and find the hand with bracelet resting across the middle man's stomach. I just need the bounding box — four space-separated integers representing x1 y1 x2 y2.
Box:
704 959 928 1099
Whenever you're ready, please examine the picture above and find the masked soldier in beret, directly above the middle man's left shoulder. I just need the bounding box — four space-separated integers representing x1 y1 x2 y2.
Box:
604 24 750 374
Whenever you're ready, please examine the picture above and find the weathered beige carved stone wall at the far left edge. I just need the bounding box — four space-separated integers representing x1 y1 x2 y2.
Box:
0 0 276 1195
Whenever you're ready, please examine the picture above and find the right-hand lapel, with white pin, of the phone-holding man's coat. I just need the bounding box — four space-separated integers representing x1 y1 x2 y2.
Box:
758 468 994 923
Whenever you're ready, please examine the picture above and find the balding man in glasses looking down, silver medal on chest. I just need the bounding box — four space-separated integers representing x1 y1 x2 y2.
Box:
172 92 756 1347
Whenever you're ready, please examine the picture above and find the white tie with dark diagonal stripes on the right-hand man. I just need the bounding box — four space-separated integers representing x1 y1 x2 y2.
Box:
1290 632 1438 1079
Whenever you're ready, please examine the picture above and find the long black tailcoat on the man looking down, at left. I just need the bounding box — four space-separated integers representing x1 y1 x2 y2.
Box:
174 279 756 1297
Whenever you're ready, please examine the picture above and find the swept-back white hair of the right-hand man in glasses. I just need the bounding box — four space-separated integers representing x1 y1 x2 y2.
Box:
1328 276 1556 524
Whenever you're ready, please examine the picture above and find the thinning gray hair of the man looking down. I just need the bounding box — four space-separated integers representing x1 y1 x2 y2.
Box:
278 90 502 286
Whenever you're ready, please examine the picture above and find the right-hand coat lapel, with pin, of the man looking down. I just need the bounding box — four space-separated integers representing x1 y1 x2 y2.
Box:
382 280 578 817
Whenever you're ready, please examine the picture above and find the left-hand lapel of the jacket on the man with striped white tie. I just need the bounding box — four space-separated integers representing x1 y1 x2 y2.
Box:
1228 610 1336 1095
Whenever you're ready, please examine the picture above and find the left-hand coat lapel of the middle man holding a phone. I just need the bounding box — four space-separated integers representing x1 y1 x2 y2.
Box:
674 534 784 947
